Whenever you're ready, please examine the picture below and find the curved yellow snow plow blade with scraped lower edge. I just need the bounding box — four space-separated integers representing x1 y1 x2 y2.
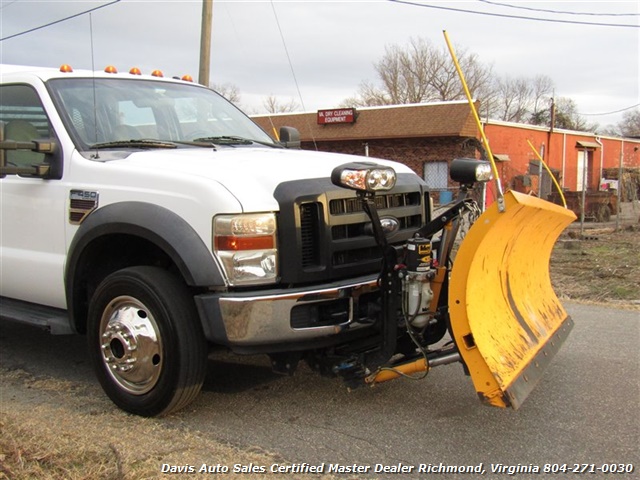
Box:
449 191 576 409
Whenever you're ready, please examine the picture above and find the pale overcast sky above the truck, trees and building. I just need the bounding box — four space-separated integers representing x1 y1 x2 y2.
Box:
0 0 640 126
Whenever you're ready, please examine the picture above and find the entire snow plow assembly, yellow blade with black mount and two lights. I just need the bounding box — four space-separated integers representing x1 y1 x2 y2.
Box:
332 159 575 409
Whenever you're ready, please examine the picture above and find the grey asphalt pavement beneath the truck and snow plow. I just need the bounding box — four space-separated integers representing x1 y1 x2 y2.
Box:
0 303 640 479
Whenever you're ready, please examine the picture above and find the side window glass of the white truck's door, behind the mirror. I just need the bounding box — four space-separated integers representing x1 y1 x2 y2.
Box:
0 85 51 167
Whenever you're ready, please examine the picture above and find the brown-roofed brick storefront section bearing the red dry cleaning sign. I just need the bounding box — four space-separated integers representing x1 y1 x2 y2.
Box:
252 102 477 189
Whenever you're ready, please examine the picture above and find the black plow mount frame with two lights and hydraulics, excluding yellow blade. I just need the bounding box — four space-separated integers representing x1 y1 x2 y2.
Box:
331 159 480 386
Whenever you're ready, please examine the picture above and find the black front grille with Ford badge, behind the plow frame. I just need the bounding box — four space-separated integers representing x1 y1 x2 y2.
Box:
275 175 428 285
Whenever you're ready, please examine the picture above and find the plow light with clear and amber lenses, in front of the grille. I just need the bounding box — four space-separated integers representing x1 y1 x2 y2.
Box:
331 162 396 192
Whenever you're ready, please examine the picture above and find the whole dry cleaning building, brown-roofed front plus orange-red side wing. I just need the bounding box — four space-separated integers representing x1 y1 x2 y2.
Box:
253 101 640 203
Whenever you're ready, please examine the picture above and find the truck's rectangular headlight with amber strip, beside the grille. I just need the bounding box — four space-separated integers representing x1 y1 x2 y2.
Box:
213 213 278 285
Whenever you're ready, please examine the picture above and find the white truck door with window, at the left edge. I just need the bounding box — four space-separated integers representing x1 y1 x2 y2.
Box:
0 84 66 308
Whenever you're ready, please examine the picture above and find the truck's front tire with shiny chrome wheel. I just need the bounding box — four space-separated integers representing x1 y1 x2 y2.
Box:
87 266 207 417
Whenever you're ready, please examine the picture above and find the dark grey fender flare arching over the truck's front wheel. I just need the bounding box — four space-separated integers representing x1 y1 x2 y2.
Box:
65 202 225 331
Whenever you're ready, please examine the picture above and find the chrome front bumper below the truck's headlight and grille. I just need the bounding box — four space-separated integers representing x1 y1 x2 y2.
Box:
196 276 378 347
